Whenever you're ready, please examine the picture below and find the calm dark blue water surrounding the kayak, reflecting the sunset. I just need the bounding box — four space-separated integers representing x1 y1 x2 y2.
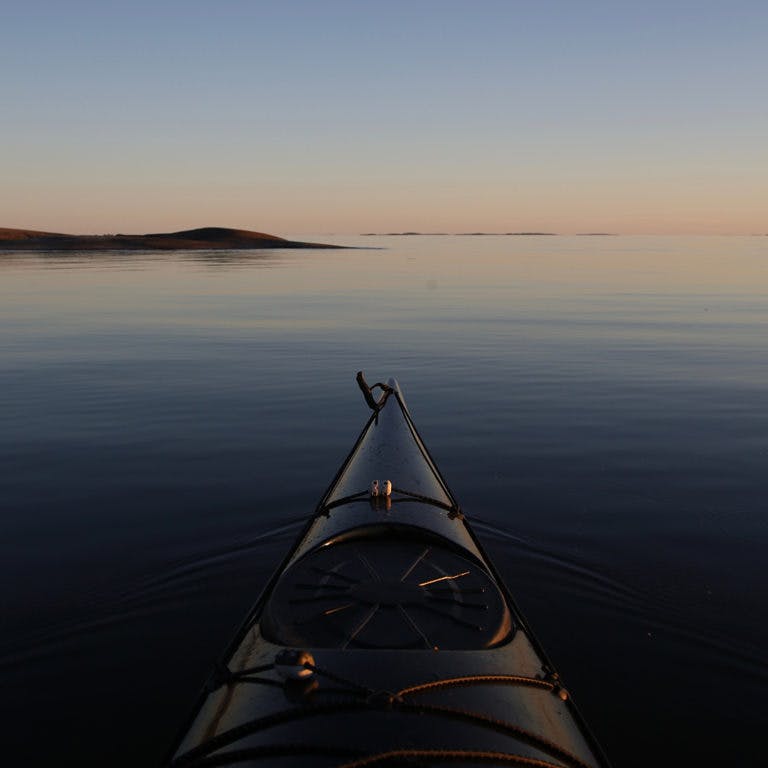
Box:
0 237 768 767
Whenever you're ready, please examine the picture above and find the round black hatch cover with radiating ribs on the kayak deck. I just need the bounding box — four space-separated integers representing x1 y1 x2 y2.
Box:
262 534 512 649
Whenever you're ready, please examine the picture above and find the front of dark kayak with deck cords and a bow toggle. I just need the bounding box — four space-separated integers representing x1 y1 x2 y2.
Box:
169 373 608 768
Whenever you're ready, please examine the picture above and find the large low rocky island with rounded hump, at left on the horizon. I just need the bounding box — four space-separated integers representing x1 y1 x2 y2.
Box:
0 227 344 251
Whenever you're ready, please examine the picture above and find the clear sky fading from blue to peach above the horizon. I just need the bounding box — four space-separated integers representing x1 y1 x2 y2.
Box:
0 0 768 235
